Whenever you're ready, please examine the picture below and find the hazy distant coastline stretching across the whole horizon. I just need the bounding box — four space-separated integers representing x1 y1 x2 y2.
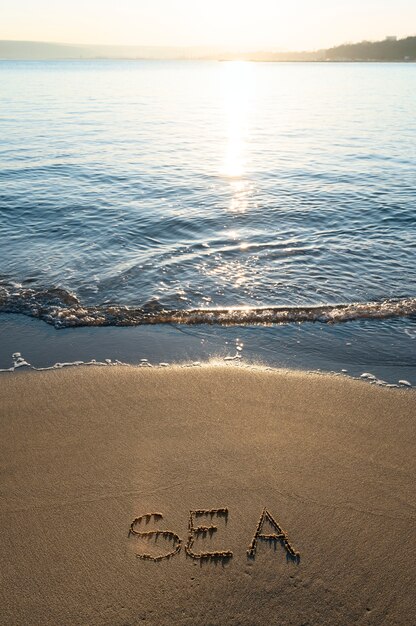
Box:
0 36 416 62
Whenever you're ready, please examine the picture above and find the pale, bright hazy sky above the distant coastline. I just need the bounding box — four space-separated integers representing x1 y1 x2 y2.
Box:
0 0 416 50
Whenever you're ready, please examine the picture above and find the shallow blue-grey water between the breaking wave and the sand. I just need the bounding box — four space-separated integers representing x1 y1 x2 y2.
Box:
0 314 416 386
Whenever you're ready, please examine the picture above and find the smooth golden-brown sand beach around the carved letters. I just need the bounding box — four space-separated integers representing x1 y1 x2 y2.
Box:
0 365 416 626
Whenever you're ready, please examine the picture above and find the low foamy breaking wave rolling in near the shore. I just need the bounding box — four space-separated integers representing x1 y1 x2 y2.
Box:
0 286 416 328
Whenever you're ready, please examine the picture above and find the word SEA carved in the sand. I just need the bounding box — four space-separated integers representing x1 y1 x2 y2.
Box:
128 508 300 563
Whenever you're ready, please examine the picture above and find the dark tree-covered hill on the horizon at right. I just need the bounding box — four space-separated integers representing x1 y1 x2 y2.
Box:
325 37 416 61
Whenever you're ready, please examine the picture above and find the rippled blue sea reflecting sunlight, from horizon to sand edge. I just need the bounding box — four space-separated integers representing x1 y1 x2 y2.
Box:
0 60 416 386
